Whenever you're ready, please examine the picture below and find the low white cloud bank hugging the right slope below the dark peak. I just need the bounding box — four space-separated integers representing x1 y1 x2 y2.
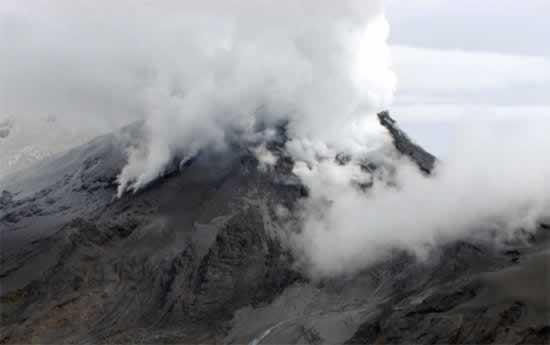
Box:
291 119 550 276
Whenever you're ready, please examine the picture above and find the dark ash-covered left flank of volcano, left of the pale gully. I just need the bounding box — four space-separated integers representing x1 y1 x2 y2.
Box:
0 132 303 343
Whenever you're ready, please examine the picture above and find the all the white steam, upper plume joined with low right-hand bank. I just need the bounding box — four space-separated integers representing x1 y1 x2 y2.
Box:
0 0 550 275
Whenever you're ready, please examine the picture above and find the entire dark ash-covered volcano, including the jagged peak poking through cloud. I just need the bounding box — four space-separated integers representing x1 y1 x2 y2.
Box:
0 113 550 344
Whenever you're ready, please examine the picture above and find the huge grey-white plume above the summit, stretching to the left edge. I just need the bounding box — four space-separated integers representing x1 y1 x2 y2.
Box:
0 0 395 193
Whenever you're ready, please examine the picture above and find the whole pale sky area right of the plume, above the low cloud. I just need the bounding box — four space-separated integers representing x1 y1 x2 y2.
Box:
386 0 550 154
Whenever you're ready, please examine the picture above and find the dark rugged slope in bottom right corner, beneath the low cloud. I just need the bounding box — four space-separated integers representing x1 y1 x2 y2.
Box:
347 243 550 344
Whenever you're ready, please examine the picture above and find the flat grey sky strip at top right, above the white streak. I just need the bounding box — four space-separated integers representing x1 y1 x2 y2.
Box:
386 0 550 56
